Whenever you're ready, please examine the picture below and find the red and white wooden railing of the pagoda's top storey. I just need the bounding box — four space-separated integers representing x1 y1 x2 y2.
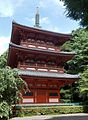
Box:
20 41 60 51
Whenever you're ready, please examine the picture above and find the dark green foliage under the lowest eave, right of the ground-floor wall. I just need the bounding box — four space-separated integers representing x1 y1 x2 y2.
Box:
60 82 80 103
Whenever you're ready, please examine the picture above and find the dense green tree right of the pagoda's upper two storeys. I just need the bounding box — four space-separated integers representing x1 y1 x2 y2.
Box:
62 29 88 74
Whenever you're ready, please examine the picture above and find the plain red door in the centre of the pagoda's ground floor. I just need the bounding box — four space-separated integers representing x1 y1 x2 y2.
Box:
36 90 47 103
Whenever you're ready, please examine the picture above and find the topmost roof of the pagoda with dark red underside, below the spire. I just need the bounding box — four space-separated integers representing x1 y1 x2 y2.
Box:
11 22 71 45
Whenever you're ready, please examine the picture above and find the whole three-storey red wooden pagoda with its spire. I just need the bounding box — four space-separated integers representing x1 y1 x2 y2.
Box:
7 11 79 104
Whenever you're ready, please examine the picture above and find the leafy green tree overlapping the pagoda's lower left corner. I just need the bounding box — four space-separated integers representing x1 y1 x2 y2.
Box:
0 67 27 119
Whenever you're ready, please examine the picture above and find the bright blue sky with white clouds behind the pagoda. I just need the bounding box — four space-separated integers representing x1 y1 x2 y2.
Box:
0 0 79 55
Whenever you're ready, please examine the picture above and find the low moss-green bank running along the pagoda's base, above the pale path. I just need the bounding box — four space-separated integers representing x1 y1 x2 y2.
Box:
16 106 87 116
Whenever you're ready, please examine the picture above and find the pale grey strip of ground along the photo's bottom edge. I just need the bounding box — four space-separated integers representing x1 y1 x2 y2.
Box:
11 113 88 120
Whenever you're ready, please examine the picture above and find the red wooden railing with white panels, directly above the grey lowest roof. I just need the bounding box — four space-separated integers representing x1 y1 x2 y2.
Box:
17 64 64 73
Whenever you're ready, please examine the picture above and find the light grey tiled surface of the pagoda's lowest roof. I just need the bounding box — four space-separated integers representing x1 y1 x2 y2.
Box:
18 70 80 79
